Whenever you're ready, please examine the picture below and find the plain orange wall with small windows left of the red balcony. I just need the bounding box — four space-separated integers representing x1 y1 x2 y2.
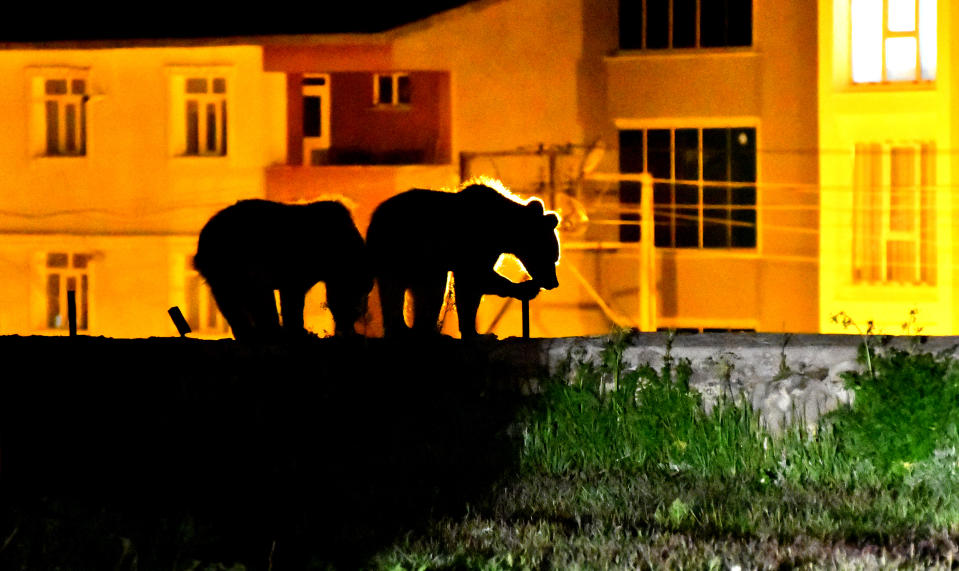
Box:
0 45 286 337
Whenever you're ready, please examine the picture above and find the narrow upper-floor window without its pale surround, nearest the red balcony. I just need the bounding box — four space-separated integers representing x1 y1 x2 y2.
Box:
183 76 227 156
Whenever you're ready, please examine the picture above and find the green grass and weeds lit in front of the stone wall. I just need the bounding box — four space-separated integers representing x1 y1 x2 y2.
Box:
377 337 959 569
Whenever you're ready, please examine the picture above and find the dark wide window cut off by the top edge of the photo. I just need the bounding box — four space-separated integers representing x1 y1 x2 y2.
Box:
619 0 753 50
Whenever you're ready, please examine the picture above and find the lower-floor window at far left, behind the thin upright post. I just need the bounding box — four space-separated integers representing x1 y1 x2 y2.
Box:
46 252 91 331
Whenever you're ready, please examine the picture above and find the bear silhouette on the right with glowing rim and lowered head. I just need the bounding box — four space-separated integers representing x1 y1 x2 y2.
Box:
366 184 559 339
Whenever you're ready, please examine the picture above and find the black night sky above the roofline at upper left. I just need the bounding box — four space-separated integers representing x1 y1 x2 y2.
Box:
0 0 478 42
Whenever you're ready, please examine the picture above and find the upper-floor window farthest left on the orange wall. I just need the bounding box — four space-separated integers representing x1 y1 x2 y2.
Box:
31 68 89 157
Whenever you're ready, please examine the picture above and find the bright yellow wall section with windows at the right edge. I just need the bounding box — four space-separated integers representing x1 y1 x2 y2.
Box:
819 0 957 334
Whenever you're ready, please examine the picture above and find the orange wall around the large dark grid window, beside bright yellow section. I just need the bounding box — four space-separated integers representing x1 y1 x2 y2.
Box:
606 0 818 331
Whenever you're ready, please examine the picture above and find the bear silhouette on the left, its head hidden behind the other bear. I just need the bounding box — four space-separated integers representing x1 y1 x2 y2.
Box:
193 199 373 341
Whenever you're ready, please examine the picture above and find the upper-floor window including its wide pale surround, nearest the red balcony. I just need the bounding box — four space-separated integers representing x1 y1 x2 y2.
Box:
167 66 236 159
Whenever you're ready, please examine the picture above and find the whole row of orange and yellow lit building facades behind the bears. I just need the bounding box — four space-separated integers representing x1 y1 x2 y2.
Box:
0 0 955 337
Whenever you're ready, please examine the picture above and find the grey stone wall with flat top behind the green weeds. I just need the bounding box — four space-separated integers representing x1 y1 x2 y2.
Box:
496 333 959 433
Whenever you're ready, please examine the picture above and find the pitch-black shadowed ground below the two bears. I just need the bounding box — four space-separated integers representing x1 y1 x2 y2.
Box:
0 337 517 569
